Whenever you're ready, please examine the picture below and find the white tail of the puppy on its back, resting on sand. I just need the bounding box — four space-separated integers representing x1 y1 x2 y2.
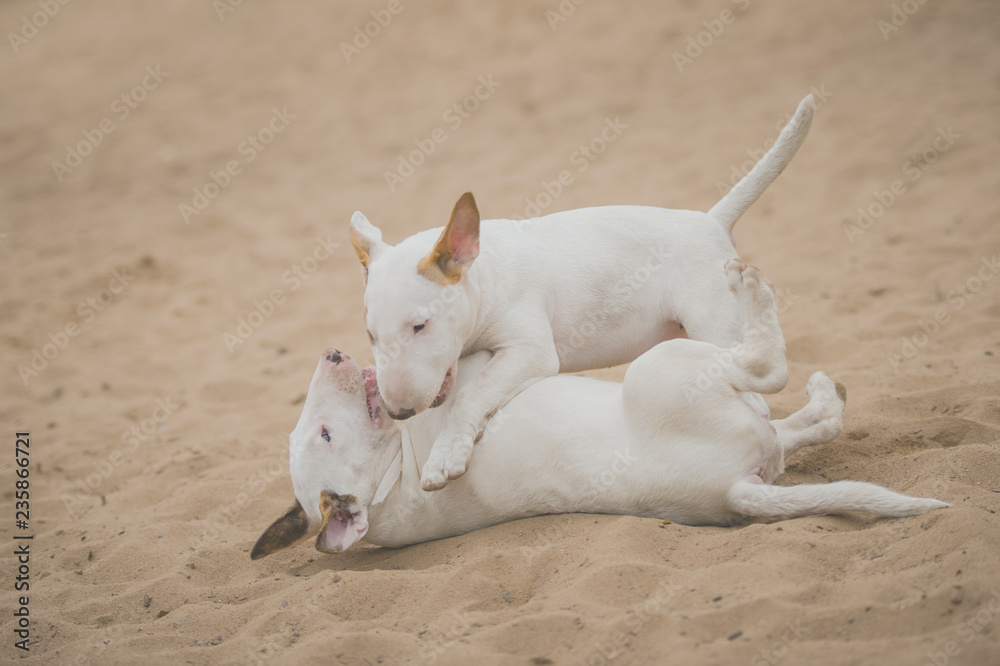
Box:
729 481 951 518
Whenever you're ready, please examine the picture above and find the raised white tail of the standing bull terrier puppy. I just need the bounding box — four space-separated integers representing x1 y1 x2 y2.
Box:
708 93 816 231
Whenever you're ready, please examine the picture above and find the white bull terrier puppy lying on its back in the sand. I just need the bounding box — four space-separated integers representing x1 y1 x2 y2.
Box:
251 260 948 559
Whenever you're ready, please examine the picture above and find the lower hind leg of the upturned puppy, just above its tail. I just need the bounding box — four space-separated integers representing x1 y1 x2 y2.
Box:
771 372 847 458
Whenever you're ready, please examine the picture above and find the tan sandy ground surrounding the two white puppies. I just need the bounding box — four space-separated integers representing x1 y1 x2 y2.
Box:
0 0 1000 665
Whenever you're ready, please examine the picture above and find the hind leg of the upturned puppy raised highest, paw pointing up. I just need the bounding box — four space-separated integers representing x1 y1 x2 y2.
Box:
726 259 788 393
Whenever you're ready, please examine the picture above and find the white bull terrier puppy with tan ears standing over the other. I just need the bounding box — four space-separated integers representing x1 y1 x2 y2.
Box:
351 95 814 490
